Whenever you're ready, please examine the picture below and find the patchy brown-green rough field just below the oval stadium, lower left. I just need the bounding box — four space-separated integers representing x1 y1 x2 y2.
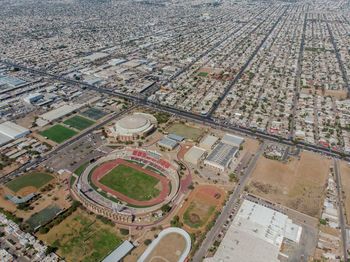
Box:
38 209 122 262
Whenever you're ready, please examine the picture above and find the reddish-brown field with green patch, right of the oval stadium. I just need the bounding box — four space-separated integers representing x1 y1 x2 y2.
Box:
179 185 225 231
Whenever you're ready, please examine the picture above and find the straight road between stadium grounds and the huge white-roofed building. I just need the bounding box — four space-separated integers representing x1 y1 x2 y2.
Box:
193 143 265 262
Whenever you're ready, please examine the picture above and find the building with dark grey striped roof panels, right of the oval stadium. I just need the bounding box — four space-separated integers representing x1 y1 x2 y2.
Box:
204 142 238 172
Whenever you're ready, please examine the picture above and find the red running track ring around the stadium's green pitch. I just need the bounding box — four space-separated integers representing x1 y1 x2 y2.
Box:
91 159 170 207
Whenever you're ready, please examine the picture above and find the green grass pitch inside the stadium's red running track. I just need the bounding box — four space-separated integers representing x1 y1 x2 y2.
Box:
100 165 160 201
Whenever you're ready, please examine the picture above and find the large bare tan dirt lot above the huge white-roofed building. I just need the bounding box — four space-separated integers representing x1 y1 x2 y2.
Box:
248 152 331 217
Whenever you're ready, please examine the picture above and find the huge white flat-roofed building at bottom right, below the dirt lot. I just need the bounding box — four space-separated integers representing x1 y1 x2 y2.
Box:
204 200 302 262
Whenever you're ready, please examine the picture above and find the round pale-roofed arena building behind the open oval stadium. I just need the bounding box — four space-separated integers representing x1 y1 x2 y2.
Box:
107 113 157 141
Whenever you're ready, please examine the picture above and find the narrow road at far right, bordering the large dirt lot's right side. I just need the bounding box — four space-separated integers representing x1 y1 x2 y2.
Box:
333 159 348 261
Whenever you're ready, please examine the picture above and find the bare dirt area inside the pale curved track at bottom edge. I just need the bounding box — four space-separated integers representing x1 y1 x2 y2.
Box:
145 233 186 262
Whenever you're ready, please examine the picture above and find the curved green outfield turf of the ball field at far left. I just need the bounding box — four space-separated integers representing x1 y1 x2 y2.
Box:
6 172 53 192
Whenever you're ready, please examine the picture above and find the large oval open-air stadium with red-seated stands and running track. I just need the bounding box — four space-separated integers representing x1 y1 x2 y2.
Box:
72 148 179 225
